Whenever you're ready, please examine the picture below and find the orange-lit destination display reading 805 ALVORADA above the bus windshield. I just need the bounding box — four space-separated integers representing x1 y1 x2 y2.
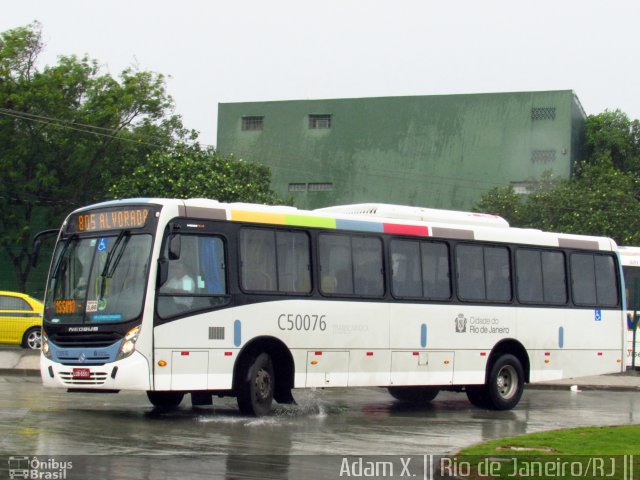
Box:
67 207 151 233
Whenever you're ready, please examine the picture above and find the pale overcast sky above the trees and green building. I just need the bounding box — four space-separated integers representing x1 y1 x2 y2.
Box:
0 0 640 145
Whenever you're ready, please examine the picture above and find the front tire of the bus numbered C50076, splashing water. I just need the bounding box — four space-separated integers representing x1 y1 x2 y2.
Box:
237 353 275 417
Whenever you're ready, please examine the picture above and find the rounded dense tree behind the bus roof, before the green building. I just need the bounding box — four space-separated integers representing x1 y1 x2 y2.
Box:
109 144 283 204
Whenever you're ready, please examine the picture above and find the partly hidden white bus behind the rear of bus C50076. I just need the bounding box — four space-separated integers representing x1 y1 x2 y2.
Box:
619 247 640 367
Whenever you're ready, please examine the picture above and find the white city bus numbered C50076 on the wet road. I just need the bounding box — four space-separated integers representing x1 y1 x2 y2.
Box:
41 199 626 415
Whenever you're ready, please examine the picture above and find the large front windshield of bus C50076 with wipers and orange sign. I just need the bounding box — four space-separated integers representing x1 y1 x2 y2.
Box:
44 230 151 324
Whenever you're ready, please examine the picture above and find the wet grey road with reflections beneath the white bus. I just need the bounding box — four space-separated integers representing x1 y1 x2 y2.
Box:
0 376 640 478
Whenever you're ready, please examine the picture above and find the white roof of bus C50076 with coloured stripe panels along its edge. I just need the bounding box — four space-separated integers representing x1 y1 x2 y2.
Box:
72 198 616 251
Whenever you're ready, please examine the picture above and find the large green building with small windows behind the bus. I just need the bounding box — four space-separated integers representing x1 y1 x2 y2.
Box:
217 90 586 210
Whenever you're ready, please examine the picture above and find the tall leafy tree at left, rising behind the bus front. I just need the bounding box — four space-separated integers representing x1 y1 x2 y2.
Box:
0 23 189 291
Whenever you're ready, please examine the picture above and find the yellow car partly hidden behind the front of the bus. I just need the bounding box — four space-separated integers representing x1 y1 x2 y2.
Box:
0 291 43 350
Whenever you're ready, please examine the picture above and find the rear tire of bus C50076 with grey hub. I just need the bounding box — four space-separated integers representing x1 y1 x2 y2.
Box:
486 354 524 410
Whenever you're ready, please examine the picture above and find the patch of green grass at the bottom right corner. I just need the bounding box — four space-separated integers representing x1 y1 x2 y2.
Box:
455 425 640 480
